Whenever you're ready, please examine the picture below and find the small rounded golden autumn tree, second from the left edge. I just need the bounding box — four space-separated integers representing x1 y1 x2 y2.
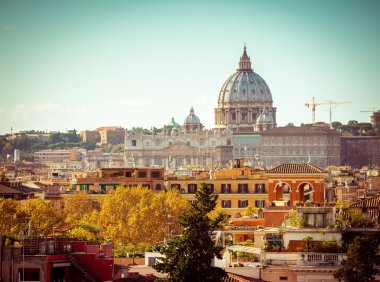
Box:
24 198 63 236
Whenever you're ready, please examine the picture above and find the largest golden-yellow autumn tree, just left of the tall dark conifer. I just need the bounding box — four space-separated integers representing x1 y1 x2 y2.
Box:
99 186 188 245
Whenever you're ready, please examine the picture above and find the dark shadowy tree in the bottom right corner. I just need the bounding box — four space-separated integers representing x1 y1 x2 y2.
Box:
334 237 380 282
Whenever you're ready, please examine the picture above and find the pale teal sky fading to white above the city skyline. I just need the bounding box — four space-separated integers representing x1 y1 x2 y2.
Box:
0 0 380 134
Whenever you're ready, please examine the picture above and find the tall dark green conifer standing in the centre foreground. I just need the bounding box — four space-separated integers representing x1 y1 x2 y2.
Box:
153 184 226 281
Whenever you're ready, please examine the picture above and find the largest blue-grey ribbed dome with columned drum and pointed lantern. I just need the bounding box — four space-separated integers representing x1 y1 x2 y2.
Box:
214 46 276 133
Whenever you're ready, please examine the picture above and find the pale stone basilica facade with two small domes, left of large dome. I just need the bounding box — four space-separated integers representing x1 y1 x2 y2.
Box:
125 108 233 169
